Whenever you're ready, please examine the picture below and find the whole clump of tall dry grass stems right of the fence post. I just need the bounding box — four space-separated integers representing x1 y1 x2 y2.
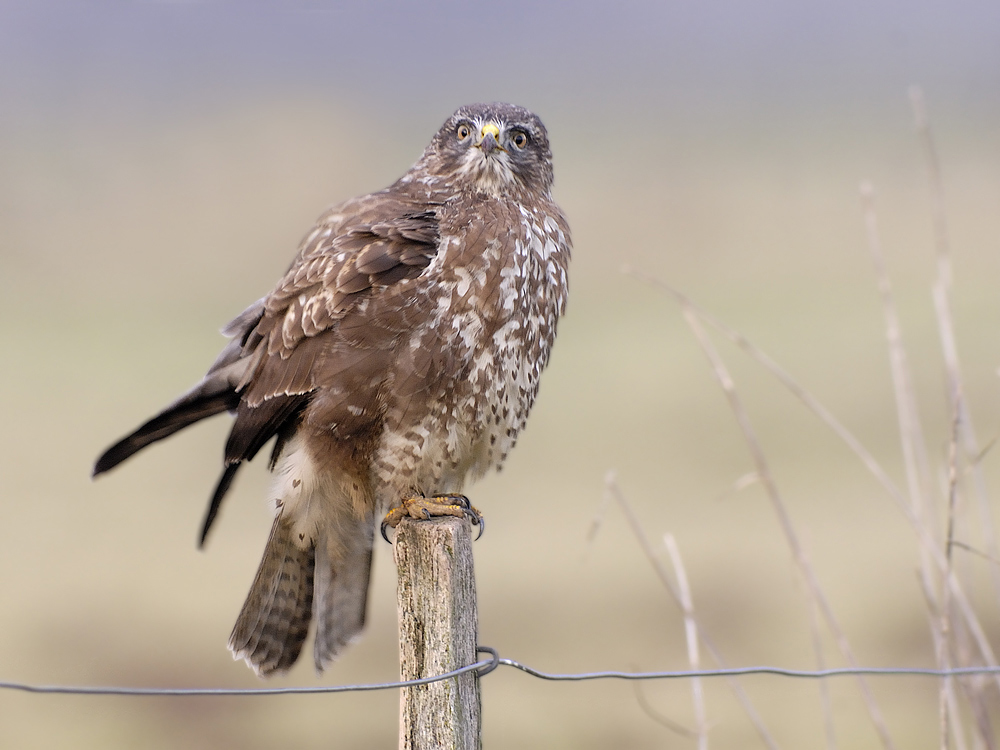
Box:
589 87 1000 750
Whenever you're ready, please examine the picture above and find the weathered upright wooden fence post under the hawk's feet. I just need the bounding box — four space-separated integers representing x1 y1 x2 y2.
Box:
393 517 482 750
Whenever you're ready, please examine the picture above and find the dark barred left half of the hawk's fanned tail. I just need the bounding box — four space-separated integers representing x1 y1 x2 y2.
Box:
229 513 315 677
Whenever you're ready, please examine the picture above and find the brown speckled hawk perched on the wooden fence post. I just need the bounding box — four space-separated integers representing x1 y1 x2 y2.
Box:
94 103 571 676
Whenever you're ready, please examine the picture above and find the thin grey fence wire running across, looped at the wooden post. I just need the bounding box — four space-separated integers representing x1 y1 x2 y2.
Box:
0 646 1000 697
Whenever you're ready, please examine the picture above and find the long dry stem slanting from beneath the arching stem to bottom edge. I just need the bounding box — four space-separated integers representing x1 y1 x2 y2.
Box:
681 305 895 748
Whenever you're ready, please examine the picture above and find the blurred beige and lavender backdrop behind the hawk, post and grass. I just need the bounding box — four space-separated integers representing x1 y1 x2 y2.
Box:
0 0 1000 748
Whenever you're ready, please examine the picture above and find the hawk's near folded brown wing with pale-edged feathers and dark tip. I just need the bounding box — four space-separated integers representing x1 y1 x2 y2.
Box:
195 200 439 541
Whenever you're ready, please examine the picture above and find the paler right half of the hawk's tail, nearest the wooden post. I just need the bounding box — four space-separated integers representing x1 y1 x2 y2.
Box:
313 517 375 672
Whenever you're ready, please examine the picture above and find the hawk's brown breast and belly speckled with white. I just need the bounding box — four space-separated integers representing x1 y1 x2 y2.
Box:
374 199 570 503
